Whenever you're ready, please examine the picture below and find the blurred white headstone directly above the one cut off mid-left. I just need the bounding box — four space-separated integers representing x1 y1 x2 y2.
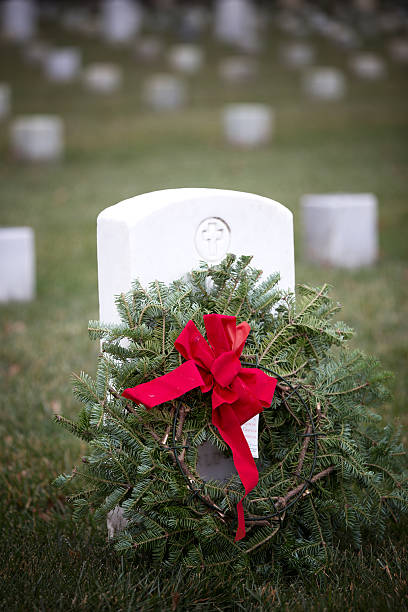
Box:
10 115 64 162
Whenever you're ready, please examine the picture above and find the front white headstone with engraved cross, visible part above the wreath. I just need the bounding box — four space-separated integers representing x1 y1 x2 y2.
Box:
98 189 294 322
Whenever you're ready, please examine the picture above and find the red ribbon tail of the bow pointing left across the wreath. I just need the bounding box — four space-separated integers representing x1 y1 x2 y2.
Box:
122 359 204 408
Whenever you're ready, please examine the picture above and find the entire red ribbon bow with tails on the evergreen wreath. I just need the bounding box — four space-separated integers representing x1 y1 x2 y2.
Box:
122 314 277 541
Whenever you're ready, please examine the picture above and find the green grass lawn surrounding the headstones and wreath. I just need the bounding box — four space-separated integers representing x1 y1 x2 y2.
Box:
0 14 408 610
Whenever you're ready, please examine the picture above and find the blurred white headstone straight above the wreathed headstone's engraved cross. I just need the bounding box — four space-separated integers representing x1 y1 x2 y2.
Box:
222 104 274 148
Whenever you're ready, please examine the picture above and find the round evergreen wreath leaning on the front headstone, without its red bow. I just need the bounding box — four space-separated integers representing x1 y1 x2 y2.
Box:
55 255 408 576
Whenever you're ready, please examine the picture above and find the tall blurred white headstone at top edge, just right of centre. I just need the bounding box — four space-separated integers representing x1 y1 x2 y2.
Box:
214 0 259 51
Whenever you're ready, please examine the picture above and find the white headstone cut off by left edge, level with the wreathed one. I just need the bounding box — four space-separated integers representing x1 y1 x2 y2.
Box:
0 227 35 303
